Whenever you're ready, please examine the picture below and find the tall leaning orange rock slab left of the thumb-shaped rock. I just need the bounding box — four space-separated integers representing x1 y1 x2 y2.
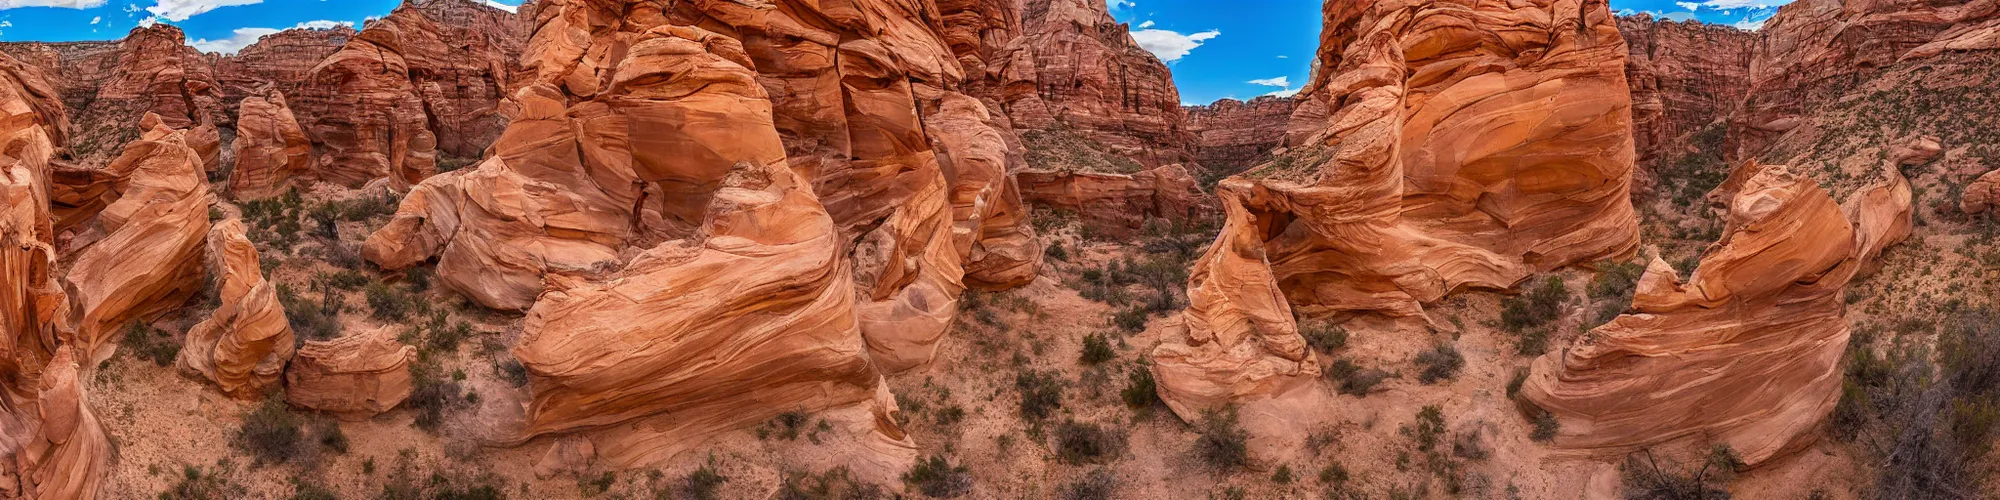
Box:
64 114 214 364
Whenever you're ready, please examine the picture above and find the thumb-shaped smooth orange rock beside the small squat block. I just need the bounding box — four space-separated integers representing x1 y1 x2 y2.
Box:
180 218 294 400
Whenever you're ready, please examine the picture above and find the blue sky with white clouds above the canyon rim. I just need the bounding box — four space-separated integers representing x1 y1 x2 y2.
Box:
0 0 1792 104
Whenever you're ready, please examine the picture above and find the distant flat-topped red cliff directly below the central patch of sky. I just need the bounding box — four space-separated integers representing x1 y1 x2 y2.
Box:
1188 96 1298 174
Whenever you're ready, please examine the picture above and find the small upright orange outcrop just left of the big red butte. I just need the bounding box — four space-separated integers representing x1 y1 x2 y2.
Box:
230 90 312 200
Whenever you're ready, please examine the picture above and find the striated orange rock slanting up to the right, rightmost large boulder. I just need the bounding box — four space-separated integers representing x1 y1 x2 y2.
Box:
1520 162 1912 466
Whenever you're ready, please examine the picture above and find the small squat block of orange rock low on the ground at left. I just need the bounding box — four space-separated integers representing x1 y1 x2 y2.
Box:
284 330 416 420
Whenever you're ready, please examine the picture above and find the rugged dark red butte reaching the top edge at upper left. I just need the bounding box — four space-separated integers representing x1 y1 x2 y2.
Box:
292 0 520 188
